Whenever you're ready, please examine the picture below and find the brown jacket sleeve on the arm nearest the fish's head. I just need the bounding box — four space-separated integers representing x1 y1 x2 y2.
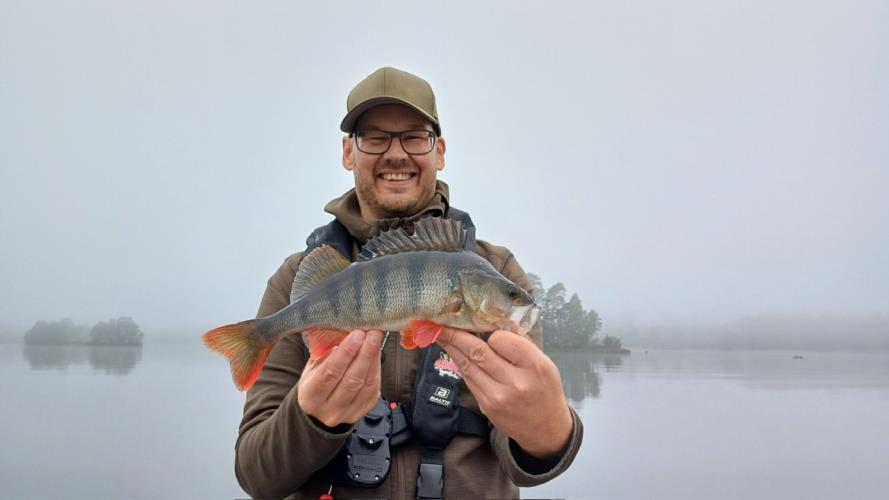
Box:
491 253 583 487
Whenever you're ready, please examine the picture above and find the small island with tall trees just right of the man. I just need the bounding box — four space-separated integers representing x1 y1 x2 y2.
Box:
528 273 623 352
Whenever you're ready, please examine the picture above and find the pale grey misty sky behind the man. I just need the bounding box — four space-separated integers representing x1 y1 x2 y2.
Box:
0 0 889 335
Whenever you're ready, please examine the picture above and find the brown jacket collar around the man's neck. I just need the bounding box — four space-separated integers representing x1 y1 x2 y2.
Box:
324 180 450 244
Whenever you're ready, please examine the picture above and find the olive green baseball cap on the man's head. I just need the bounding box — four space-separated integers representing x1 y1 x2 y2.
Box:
340 67 441 135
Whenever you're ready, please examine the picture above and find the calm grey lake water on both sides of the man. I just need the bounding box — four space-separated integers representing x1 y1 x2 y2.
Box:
0 344 889 499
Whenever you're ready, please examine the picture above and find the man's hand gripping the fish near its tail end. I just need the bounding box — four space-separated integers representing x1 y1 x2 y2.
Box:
298 330 383 427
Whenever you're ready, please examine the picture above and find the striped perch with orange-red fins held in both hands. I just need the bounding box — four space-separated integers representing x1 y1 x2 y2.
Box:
203 217 540 391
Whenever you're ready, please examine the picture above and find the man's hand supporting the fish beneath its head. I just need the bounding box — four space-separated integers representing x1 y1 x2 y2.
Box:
438 328 573 458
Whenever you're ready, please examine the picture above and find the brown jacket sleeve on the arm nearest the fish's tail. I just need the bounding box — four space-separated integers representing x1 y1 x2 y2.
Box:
235 254 351 498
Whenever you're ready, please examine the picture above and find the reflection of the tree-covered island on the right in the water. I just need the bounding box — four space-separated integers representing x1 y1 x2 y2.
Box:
547 350 623 408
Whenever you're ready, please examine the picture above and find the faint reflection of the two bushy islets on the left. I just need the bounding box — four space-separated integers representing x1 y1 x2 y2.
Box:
22 344 142 375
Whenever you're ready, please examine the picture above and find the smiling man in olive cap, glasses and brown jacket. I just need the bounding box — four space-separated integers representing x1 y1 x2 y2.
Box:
235 68 582 499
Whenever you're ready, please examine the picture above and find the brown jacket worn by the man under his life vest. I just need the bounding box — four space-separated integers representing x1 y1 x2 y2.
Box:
235 181 583 500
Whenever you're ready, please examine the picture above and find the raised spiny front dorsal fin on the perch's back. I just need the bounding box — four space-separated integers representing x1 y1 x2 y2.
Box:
358 217 466 261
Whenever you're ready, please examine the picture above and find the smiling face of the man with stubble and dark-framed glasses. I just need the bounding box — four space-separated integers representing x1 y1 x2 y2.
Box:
343 104 445 219
